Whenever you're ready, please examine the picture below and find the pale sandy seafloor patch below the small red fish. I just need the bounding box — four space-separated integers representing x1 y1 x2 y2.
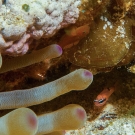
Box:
66 99 135 135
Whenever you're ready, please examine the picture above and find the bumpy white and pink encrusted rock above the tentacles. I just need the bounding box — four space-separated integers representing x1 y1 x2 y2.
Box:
0 0 81 56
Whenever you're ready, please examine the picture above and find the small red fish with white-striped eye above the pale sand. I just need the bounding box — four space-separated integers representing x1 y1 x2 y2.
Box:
94 87 115 106
